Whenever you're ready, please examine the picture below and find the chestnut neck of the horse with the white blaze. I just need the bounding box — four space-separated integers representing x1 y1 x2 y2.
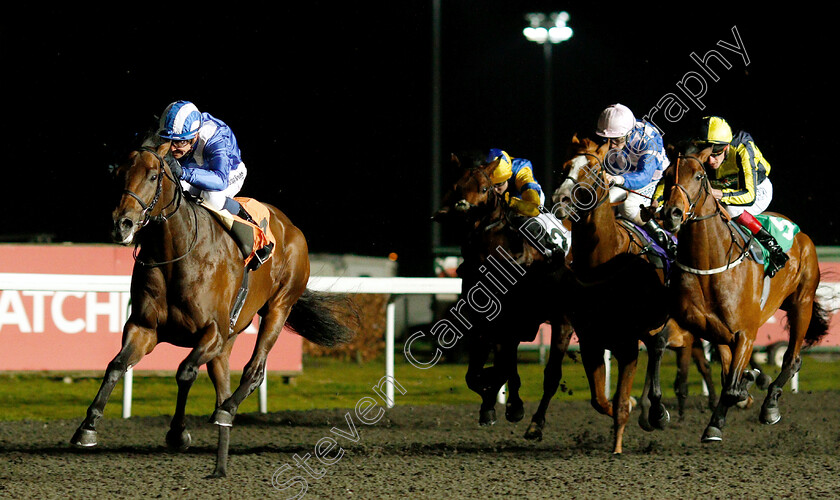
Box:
572 194 627 269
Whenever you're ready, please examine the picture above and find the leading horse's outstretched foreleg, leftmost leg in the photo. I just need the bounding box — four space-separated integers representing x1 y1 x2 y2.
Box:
70 323 157 448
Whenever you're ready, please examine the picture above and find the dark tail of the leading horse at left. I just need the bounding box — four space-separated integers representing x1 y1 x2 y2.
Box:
286 289 361 347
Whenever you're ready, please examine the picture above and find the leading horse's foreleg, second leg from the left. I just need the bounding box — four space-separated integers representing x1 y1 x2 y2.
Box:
166 323 232 451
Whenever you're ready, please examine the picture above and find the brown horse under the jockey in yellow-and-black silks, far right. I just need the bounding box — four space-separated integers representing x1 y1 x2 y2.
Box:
661 145 828 442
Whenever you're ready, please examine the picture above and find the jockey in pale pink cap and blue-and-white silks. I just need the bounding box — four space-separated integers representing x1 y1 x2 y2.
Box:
596 104 676 256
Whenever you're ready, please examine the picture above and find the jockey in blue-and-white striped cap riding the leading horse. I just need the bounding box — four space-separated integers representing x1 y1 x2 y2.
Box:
158 101 273 270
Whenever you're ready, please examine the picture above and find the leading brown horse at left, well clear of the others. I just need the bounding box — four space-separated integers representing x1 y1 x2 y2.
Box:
71 141 354 477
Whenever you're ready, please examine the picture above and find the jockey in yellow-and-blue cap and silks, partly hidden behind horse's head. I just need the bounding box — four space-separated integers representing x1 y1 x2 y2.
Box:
487 148 545 217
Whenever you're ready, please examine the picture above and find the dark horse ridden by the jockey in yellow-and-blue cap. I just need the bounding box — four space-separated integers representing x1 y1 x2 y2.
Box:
433 154 573 439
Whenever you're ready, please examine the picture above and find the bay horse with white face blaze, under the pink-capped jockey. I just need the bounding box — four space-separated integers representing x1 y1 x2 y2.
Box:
552 135 714 454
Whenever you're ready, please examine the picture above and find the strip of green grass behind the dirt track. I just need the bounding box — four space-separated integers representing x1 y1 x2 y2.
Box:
0 352 840 421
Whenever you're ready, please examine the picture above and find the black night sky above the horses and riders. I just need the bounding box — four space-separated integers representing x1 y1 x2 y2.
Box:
0 0 840 275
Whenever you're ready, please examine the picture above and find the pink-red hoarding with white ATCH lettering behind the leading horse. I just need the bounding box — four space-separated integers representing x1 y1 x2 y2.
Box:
0 245 303 374
